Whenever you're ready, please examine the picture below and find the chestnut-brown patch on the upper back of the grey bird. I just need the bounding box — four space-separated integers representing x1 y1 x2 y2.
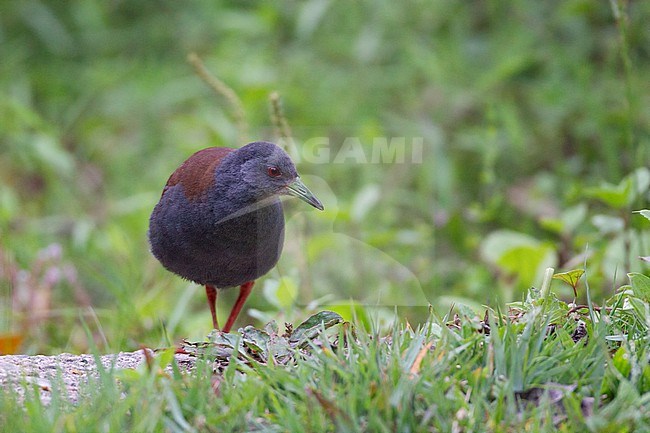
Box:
162 147 235 200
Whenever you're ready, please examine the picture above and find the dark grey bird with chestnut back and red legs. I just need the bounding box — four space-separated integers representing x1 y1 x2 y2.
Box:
148 141 324 332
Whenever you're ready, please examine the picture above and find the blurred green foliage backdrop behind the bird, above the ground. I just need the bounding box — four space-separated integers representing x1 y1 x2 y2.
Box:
0 0 650 353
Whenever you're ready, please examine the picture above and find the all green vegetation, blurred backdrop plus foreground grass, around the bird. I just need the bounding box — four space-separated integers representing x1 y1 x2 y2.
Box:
0 0 650 431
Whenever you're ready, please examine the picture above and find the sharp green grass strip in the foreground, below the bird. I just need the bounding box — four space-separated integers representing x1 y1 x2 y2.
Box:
0 275 650 432
